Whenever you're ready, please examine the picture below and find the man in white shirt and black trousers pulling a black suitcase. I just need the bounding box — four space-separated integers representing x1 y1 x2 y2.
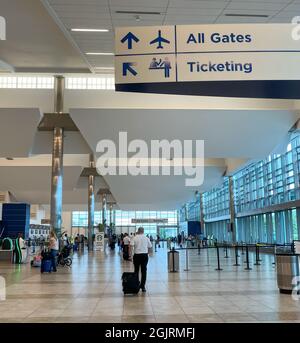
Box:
130 227 152 292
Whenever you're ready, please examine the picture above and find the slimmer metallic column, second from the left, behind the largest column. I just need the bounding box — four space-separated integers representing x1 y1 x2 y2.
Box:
88 154 95 251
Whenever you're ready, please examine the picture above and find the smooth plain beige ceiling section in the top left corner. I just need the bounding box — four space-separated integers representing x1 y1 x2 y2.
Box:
0 0 90 73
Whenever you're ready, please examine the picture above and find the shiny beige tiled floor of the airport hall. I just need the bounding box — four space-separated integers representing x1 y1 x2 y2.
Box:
0 248 300 323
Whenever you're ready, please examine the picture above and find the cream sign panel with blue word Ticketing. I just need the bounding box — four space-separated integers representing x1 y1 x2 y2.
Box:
177 52 300 81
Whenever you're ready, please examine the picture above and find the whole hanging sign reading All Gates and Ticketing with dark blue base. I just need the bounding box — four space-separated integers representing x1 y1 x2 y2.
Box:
115 24 300 98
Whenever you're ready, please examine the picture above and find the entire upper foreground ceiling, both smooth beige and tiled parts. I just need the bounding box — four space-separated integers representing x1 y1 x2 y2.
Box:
0 0 300 73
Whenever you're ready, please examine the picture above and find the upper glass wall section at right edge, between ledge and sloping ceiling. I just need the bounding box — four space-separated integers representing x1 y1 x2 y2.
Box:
233 136 300 212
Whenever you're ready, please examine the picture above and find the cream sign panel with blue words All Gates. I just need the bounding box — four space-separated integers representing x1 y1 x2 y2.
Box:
176 24 300 53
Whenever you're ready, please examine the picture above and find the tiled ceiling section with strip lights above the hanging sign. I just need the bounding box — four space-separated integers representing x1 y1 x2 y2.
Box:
43 0 300 72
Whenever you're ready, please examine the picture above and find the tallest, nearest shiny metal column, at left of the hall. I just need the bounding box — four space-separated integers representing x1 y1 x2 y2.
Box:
50 76 65 236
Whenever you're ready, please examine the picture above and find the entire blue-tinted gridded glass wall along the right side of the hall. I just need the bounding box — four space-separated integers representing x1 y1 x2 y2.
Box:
180 135 300 244
